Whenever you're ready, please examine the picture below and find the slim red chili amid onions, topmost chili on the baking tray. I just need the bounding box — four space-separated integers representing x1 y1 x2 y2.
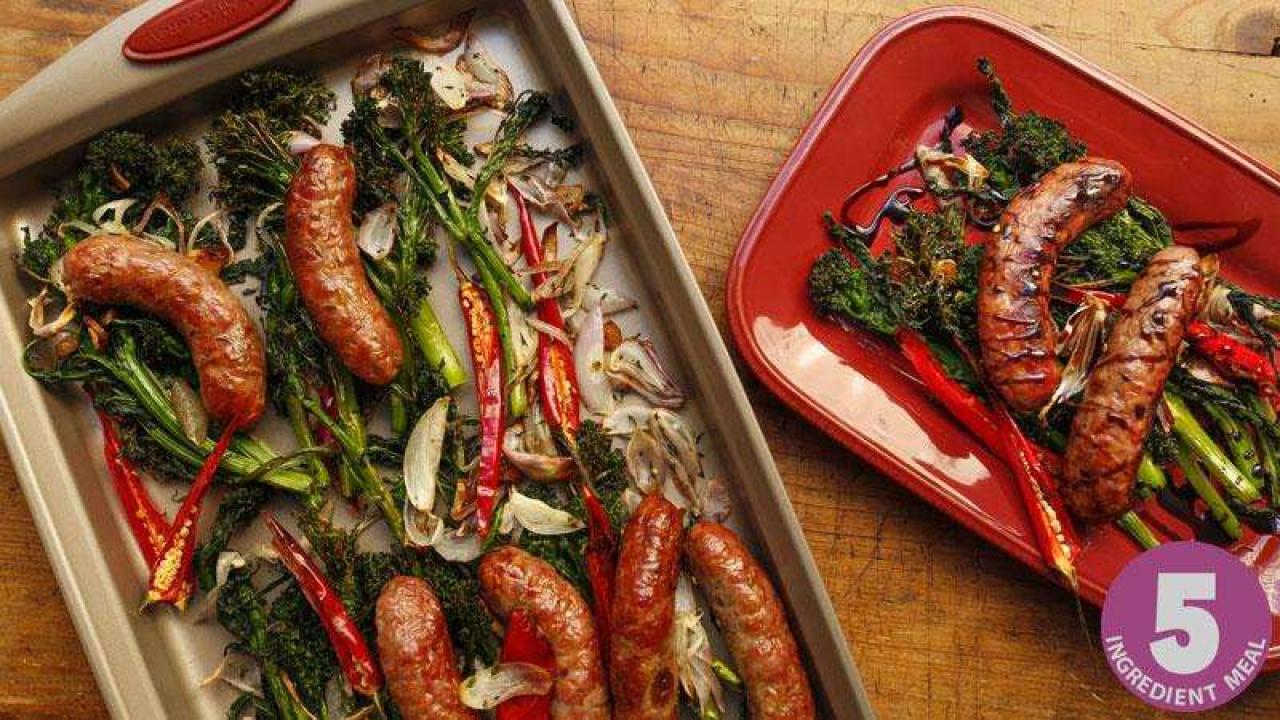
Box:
508 184 581 436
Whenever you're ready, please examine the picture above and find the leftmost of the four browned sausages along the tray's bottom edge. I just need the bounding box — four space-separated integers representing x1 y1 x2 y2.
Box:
374 575 477 720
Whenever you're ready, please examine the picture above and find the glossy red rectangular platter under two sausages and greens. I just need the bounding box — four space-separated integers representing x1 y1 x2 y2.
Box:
728 8 1280 665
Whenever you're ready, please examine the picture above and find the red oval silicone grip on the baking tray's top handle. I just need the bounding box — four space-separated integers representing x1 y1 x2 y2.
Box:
123 0 293 63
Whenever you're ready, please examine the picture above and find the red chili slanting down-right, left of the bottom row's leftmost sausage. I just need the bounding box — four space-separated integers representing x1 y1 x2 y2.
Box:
265 512 383 697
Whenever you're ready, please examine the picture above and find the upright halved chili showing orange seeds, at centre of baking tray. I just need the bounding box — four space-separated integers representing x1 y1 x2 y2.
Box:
458 278 506 537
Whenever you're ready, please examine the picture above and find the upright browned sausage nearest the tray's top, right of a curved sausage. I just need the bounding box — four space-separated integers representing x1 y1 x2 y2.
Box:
284 145 404 386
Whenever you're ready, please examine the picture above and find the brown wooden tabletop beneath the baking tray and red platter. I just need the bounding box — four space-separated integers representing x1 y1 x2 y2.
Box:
0 0 1280 717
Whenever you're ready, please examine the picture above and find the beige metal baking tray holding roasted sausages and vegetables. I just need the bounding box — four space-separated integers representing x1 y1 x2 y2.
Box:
0 0 870 719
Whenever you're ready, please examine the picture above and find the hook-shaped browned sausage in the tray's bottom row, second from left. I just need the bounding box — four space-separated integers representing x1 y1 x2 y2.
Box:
480 546 609 720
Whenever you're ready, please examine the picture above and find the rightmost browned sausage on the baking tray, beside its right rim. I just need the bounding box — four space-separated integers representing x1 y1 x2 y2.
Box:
685 520 814 720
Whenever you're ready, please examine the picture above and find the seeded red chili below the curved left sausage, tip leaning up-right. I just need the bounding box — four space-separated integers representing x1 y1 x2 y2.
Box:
142 420 239 610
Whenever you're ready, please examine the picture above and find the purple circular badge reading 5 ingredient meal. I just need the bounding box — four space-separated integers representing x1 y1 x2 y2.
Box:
1102 542 1271 712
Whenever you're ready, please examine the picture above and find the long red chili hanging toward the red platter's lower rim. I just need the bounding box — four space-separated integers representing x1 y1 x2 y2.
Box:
896 328 1080 579
